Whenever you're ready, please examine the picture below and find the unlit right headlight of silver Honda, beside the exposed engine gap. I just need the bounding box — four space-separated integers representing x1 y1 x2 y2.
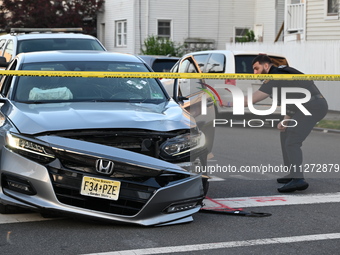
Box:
160 132 205 157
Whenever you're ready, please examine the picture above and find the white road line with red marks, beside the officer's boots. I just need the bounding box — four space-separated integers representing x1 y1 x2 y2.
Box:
204 192 340 209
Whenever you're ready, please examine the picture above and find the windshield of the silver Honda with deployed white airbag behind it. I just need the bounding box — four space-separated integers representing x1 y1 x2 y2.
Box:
14 61 167 104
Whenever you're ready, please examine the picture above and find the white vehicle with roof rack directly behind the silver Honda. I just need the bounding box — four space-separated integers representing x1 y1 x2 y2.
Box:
0 28 106 63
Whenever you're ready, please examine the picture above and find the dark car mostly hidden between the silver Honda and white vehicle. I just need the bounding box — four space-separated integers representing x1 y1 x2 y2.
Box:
138 55 179 72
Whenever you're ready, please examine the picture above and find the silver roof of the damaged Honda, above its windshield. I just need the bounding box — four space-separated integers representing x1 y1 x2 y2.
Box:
17 50 144 64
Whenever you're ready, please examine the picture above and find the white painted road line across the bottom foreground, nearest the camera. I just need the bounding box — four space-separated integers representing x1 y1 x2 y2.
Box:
81 233 340 255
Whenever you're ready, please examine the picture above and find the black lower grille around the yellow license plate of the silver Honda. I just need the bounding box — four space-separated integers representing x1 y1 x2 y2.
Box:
49 167 157 216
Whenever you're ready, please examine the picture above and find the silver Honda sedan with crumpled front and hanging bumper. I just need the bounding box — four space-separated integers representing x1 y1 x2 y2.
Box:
0 51 211 226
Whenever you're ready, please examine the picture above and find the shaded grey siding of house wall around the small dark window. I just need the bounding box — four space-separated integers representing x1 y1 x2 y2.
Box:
148 0 254 49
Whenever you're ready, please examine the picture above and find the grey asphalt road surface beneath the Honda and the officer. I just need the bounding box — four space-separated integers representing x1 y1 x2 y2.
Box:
0 127 340 255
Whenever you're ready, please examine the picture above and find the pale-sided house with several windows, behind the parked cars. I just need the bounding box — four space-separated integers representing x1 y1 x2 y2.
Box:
97 0 285 54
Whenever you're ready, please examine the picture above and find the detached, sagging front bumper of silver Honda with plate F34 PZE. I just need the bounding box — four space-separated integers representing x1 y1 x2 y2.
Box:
0 136 205 226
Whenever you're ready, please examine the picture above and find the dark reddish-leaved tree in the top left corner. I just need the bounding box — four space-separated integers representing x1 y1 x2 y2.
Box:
0 0 104 34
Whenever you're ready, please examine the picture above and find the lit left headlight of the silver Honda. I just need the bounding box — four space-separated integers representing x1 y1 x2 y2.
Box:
6 133 55 163
